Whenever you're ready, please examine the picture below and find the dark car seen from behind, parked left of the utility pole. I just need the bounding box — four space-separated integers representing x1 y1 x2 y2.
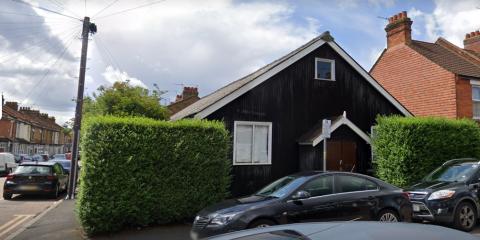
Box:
3 162 68 200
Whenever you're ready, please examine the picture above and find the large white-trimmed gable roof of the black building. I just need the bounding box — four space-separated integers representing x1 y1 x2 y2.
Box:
170 31 412 120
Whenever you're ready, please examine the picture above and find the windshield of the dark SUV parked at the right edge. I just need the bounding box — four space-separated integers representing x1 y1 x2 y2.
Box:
424 163 479 182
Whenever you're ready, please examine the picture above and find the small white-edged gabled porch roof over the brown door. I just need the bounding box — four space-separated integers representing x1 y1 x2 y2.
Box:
297 112 371 147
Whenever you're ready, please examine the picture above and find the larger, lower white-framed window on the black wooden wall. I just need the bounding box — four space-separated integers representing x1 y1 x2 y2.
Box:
233 121 272 165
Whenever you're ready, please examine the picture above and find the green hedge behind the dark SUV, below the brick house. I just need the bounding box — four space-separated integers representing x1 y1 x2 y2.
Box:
373 116 480 187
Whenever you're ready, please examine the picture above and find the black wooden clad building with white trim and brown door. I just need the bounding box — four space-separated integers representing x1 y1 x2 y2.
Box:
171 32 411 196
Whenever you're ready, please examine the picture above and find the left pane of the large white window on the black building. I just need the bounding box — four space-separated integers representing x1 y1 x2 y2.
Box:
235 125 253 163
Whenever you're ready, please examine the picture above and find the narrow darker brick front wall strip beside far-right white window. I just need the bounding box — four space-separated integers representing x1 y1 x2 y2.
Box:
456 77 473 118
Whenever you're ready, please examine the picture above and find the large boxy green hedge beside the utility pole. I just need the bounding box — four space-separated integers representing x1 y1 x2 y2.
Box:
77 116 231 235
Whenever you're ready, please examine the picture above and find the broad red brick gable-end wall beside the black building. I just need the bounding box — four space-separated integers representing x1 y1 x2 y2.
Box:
371 44 457 118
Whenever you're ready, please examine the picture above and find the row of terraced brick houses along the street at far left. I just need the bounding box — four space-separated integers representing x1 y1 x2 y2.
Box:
0 101 71 154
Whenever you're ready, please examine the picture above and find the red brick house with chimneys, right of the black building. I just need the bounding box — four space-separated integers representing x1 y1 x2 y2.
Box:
370 12 480 119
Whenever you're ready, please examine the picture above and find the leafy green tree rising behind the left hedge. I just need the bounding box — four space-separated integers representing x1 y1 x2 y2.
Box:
83 80 169 120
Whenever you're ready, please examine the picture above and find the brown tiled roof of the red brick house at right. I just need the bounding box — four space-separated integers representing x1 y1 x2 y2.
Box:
409 39 480 78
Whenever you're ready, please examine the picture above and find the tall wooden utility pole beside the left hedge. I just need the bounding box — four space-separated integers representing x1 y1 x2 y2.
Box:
67 17 96 199
